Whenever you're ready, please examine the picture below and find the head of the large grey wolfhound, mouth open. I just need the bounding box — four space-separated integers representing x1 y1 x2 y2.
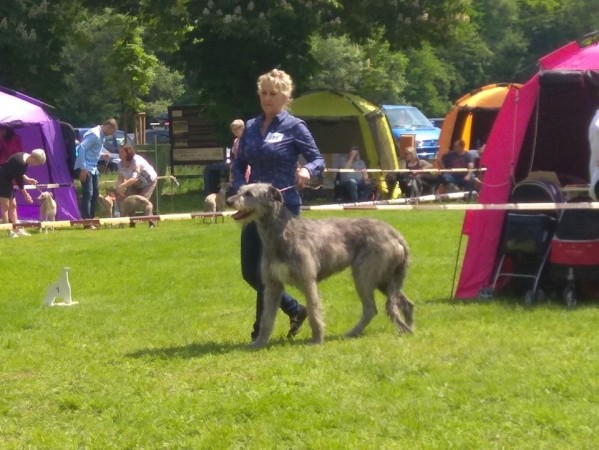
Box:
227 183 283 223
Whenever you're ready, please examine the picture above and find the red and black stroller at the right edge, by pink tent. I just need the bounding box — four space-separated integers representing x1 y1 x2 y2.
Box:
549 209 599 307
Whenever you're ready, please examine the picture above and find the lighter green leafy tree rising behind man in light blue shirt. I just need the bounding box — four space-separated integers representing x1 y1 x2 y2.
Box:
57 9 184 124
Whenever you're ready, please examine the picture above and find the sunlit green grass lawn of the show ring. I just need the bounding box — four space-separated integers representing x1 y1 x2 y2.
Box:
0 211 599 449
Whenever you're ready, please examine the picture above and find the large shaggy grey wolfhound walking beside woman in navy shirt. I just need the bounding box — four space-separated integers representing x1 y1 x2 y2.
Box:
227 183 414 347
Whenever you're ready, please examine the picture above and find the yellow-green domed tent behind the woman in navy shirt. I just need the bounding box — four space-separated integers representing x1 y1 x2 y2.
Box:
288 90 399 193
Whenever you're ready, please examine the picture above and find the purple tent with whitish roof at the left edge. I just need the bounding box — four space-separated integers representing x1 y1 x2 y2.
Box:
0 88 81 220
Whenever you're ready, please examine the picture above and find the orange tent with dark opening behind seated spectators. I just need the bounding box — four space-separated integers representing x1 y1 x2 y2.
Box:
437 83 521 160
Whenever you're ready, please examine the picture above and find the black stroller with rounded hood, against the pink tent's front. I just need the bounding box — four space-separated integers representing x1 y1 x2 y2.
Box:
491 179 563 305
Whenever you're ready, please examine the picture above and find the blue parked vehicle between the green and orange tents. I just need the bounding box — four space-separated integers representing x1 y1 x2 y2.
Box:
382 105 441 160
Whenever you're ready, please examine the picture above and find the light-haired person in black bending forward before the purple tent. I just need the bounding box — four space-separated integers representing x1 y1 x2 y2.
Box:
0 149 46 237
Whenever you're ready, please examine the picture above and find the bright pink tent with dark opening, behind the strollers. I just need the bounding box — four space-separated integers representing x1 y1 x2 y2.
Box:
456 36 599 299
